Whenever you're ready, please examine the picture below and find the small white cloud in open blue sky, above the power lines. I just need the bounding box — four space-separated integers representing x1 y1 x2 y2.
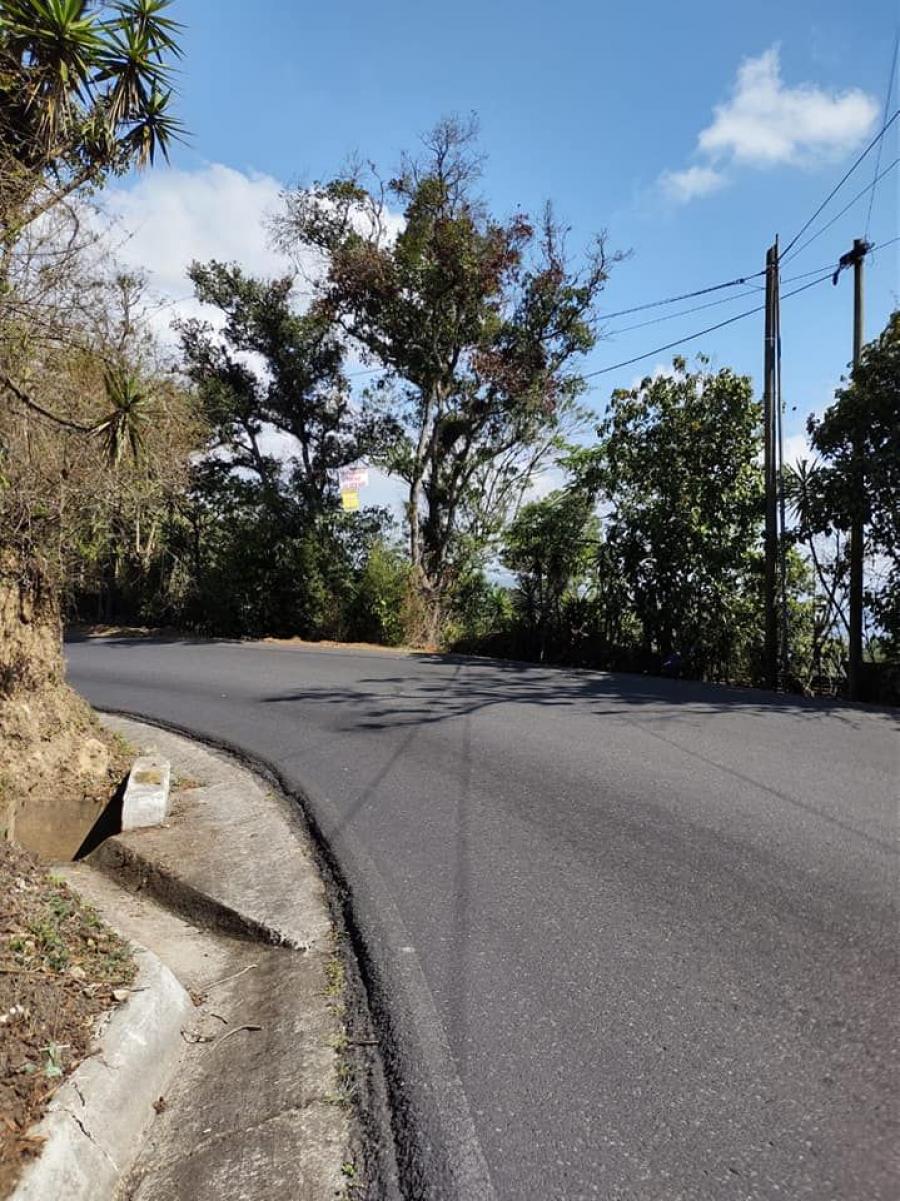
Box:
660 46 878 203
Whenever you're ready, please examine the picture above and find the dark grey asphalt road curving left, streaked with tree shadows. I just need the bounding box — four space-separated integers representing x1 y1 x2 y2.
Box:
68 640 900 1201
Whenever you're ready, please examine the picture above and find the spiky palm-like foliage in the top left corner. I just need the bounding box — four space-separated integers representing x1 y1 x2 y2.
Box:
0 0 183 235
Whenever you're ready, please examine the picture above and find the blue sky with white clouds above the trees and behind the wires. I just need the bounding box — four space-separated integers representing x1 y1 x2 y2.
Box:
106 0 900 492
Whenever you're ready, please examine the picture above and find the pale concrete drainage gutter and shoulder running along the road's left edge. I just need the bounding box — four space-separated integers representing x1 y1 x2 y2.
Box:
51 717 377 1201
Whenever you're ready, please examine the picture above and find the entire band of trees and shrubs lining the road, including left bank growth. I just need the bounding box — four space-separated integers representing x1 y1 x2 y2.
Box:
0 0 900 864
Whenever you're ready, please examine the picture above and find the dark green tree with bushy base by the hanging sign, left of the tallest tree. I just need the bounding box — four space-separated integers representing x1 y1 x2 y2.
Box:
175 262 400 638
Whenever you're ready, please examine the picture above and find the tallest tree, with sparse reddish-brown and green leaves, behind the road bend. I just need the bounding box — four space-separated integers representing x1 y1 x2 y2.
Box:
275 120 610 641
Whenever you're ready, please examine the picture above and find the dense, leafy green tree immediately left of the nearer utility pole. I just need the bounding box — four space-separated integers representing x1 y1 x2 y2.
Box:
573 358 762 677
